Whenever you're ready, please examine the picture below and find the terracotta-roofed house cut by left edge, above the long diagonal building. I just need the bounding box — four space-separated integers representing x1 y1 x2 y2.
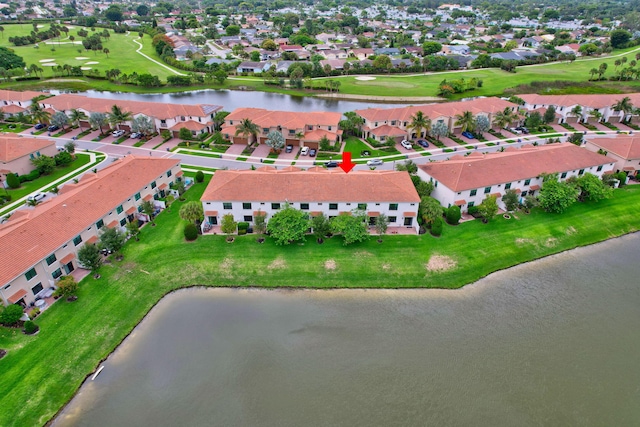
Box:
0 135 58 176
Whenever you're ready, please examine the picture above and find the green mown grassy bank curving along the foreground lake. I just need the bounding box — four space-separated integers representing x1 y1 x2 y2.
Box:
0 178 640 426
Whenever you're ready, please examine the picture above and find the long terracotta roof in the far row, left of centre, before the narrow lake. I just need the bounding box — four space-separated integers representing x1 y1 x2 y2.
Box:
42 94 222 119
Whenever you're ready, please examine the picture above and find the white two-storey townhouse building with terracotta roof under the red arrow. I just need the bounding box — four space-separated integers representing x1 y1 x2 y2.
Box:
200 166 420 232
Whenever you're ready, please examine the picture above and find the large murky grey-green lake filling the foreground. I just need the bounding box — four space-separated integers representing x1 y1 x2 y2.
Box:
55 234 640 426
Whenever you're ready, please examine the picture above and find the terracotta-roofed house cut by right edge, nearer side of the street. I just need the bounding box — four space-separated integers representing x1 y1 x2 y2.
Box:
585 135 640 176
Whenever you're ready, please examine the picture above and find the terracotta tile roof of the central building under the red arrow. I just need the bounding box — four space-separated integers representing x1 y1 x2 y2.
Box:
200 168 420 203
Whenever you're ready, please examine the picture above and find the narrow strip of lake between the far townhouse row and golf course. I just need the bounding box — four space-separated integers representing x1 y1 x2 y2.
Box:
65 90 407 113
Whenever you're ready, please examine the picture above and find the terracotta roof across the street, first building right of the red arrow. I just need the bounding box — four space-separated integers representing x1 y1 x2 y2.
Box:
355 98 517 126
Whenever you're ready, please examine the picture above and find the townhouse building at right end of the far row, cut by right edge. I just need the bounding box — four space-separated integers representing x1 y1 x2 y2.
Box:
520 93 640 123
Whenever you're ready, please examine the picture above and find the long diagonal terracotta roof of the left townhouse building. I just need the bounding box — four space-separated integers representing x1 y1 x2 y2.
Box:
0 156 179 284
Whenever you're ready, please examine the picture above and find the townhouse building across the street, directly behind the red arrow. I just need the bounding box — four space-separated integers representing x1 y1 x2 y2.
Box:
222 108 342 149
